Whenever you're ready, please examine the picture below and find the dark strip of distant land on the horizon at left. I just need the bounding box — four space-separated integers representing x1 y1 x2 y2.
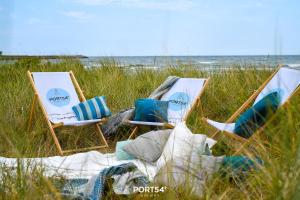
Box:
0 55 88 60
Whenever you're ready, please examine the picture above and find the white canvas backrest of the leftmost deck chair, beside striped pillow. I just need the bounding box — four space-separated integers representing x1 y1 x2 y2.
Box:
32 72 80 123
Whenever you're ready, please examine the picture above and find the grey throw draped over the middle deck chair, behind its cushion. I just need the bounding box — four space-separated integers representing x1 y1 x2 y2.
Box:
102 76 179 137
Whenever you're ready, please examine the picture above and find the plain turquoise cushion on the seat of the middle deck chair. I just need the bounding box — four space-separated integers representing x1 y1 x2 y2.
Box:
134 99 169 122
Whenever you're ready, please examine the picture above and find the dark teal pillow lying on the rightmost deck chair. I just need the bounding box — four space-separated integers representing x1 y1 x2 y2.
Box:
234 92 280 138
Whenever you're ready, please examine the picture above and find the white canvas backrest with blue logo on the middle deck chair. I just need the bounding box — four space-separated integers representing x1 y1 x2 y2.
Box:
160 78 207 124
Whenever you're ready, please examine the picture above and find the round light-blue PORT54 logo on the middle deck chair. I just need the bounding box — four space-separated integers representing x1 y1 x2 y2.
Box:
169 92 190 111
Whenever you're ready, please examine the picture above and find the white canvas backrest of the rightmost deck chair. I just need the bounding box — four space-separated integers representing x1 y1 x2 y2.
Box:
254 65 300 105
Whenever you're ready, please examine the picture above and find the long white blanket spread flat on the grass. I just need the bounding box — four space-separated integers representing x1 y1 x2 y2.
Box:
0 151 156 181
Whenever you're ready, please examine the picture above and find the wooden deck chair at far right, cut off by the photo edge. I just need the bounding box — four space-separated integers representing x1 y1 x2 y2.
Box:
203 65 300 152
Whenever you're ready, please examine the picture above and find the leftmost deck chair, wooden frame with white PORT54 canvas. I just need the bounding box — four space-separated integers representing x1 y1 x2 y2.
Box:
27 71 108 155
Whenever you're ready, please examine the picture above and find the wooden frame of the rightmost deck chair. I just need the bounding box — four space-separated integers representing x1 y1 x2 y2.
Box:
202 64 300 154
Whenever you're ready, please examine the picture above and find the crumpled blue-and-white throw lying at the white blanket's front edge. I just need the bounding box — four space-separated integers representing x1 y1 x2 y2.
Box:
62 163 150 200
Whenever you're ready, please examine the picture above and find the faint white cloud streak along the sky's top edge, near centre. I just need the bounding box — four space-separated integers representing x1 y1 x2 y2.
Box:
73 0 195 11
